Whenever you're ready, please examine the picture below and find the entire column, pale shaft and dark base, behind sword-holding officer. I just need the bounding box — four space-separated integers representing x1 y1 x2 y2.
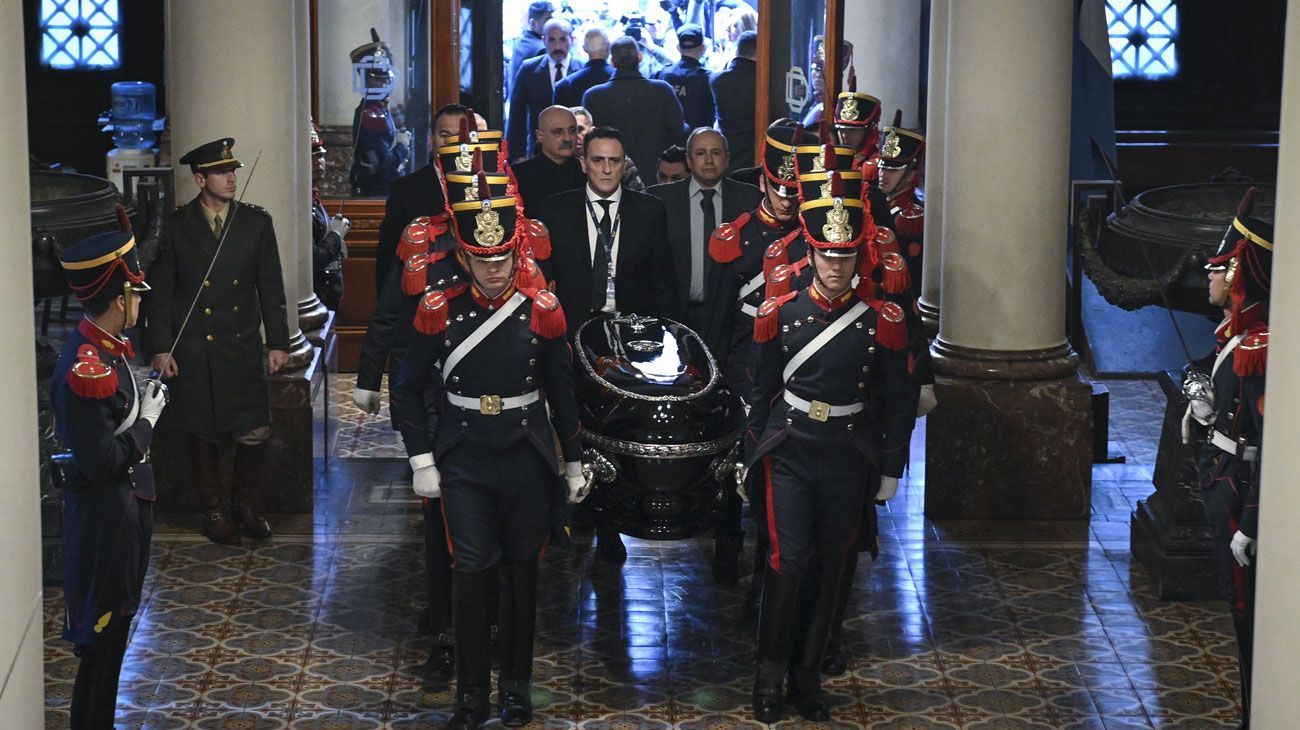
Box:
162 0 324 512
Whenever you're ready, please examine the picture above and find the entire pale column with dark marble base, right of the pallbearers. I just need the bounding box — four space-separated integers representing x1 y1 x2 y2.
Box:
926 0 1092 520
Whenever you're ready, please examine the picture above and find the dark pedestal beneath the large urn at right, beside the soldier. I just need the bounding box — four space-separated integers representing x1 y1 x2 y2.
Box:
1128 371 1219 600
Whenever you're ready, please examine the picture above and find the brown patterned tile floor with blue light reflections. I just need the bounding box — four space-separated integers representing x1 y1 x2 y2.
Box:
46 375 1238 730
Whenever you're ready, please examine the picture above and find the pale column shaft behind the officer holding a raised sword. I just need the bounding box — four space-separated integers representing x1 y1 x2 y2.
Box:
166 0 312 368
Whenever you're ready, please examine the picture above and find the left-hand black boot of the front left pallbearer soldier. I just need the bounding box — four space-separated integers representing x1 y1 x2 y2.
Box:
447 570 497 730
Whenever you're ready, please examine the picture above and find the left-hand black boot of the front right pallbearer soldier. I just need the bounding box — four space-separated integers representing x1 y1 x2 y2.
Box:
754 568 800 724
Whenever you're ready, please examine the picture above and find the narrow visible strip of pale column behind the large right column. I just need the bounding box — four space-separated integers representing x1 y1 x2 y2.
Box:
917 0 952 338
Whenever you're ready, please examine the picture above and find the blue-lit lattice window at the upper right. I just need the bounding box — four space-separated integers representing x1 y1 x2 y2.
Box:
1106 0 1178 79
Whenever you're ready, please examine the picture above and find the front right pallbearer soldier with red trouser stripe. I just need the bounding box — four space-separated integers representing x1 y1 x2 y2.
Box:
745 173 915 722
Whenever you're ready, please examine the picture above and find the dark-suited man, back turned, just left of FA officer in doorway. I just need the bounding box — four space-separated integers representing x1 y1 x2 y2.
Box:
582 35 686 186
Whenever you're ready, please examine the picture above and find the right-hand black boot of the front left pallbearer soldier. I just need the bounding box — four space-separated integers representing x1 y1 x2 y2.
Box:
501 561 537 727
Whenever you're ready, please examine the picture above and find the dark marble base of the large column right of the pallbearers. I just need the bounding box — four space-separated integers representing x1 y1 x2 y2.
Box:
926 339 1092 520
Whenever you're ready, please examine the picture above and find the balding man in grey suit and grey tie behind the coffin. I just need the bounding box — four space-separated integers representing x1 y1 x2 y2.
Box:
646 127 763 583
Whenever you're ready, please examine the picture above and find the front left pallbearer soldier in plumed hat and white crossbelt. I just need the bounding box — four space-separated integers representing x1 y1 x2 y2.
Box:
393 173 588 729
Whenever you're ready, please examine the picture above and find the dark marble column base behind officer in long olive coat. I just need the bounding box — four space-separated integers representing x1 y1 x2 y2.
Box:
151 344 326 513
